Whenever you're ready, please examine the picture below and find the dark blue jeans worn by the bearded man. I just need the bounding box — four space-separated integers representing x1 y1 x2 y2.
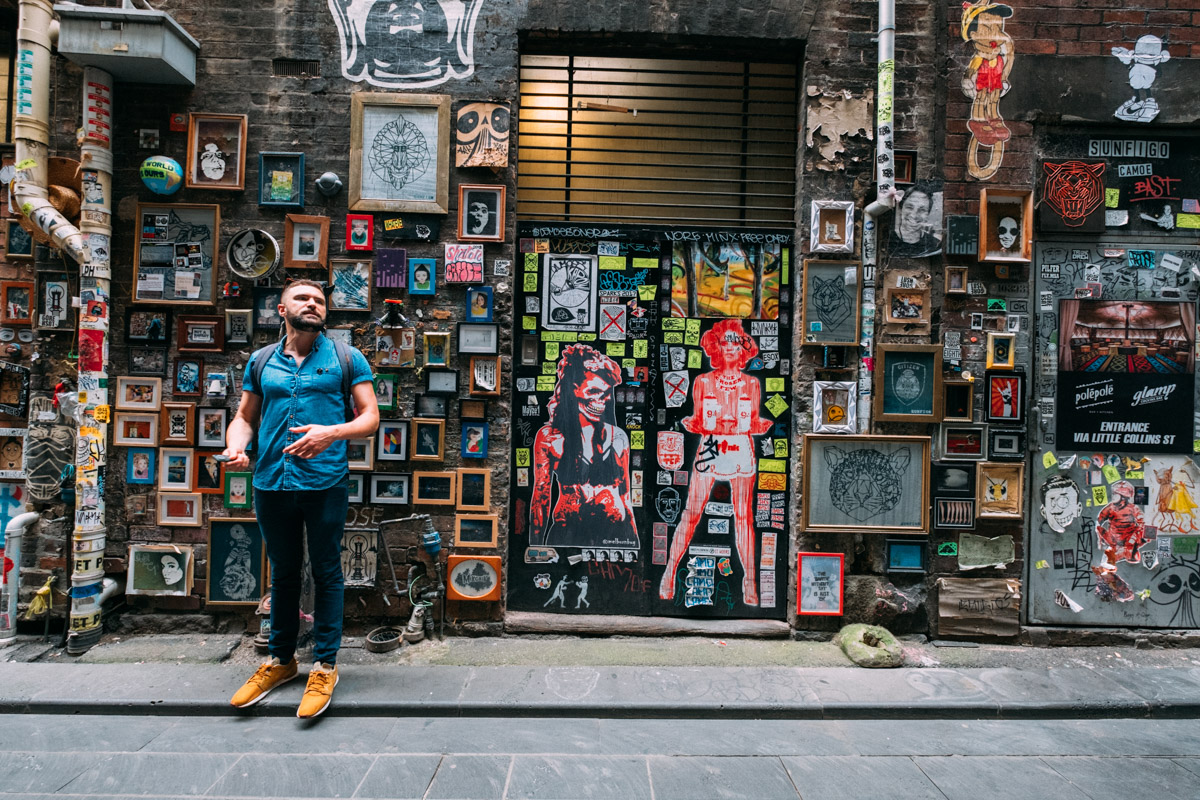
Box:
254 481 348 664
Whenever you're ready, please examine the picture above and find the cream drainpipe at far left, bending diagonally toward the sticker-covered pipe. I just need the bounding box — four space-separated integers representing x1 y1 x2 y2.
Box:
11 0 88 264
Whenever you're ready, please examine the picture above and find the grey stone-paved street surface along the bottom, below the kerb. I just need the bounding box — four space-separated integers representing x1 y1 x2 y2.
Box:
0 714 1200 800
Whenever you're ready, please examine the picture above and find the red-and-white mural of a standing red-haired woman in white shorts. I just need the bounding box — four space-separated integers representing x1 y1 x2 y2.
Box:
659 319 770 606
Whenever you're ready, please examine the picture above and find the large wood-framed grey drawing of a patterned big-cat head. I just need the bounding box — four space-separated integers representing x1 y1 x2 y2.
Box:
802 433 930 533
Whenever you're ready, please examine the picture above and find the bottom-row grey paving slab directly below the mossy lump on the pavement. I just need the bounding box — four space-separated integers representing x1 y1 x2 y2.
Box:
780 756 944 800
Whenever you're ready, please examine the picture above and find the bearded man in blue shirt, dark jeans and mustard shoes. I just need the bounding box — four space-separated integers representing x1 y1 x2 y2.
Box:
224 281 379 718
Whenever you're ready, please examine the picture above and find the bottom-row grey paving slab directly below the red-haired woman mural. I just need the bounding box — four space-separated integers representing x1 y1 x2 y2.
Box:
649 757 799 800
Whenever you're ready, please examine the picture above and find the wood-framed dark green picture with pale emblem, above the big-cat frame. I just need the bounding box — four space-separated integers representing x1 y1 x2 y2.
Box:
875 344 942 422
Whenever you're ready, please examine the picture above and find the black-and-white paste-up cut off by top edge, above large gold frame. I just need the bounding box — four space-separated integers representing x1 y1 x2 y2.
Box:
329 0 484 89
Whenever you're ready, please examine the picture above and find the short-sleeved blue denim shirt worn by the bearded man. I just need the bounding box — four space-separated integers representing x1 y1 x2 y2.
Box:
242 335 371 492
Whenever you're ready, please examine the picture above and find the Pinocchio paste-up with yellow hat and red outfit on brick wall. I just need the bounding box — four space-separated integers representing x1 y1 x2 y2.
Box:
961 0 1014 180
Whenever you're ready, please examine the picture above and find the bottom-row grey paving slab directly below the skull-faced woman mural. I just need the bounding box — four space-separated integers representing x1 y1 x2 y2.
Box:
508 756 662 800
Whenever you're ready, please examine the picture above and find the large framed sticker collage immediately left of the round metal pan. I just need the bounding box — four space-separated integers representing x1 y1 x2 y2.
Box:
133 203 220 306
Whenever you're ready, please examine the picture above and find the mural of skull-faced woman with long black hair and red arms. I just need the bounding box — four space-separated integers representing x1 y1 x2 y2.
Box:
529 344 640 551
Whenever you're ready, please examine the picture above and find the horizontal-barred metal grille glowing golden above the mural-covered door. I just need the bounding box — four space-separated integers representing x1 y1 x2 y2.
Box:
517 55 797 228
